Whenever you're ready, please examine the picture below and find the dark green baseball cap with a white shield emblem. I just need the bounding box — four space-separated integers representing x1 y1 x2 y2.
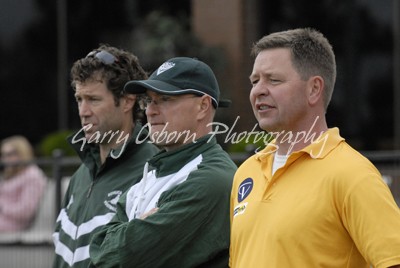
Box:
124 57 230 108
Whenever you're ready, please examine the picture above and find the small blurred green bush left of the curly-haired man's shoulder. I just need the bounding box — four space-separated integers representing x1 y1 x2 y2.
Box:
38 130 76 156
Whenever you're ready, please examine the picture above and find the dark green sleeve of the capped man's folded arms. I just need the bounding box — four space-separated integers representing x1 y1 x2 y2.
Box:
90 174 231 268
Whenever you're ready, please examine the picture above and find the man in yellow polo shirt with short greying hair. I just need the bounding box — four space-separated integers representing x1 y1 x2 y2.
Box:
230 28 400 268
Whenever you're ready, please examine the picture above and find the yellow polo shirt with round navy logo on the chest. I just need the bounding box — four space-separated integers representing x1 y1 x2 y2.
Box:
230 128 400 268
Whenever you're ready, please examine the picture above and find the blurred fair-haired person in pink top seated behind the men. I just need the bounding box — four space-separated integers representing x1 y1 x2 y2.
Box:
0 136 47 232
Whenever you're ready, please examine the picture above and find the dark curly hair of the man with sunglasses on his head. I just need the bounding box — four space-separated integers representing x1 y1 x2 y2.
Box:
70 44 148 120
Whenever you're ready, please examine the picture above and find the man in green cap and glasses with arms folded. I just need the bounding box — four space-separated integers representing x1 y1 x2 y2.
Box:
90 57 236 268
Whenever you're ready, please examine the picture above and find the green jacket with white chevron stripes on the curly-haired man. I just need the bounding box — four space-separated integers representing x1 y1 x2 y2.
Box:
53 124 158 268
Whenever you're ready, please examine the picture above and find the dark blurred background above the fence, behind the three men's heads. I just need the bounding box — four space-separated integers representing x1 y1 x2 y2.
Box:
0 0 400 155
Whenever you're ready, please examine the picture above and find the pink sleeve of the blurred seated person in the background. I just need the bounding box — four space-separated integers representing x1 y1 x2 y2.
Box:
2 168 46 222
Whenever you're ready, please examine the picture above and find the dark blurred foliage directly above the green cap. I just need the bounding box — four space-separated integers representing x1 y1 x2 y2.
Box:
131 11 225 71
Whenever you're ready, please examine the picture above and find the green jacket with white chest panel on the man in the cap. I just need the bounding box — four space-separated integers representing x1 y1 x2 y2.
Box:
90 135 236 268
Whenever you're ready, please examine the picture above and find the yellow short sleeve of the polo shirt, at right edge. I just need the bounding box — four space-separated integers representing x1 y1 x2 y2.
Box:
342 173 400 268
